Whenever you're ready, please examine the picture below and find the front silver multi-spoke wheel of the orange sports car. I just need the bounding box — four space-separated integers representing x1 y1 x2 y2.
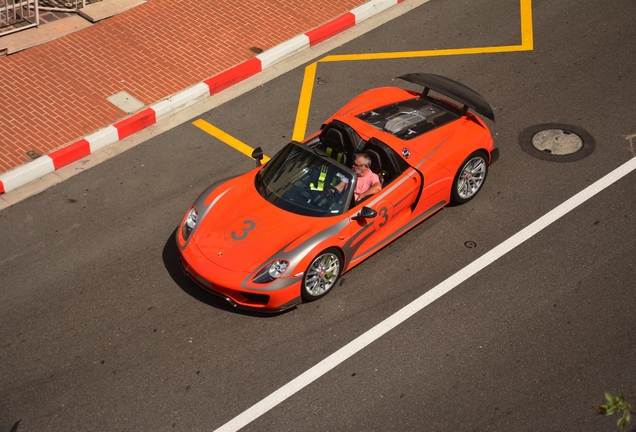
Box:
300 248 343 302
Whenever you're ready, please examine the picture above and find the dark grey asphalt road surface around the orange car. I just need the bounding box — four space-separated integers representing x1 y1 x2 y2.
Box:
0 0 636 432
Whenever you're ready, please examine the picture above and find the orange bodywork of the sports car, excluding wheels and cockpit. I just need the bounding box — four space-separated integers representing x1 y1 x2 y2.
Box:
176 74 497 311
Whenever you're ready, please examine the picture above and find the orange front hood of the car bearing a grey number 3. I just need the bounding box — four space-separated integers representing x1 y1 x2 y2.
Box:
193 177 318 272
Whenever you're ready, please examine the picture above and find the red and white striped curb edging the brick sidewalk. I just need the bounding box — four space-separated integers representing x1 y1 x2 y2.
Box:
0 0 404 194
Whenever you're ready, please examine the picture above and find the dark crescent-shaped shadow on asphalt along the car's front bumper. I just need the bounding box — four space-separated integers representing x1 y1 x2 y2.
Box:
161 227 296 318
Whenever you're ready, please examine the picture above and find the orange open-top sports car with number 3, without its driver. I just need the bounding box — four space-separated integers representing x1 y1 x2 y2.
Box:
176 73 498 312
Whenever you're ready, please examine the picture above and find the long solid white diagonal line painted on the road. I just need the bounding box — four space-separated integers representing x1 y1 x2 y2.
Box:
217 158 636 432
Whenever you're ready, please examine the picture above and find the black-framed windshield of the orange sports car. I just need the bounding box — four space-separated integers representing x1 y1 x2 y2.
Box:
256 143 355 217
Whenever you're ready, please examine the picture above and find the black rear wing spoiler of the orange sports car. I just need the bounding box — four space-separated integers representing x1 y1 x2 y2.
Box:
398 73 495 121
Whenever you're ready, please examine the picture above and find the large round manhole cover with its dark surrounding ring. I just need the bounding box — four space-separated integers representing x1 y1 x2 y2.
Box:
519 123 595 162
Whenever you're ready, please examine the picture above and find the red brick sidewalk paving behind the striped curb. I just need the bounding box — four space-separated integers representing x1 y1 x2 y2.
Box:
0 0 367 174
